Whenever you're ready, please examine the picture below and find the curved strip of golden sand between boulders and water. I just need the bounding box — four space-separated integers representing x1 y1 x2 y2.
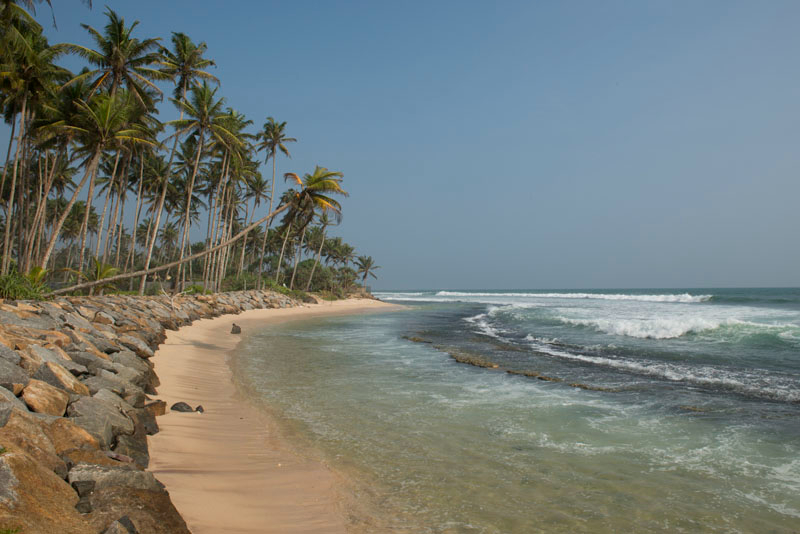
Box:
149 299 395 534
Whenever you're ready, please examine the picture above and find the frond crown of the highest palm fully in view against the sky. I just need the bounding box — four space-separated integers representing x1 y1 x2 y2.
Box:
66 7 169 109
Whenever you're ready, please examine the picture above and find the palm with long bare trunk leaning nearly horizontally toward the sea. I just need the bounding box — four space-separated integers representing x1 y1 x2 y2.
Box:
51 167 347 295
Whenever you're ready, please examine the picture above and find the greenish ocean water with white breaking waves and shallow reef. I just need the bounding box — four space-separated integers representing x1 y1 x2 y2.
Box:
234 289 800 533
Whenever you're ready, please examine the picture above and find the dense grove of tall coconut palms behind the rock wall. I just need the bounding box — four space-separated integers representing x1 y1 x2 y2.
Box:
0 0 379 295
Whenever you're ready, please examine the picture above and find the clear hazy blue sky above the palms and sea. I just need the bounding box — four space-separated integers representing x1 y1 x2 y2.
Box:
0 0 800 289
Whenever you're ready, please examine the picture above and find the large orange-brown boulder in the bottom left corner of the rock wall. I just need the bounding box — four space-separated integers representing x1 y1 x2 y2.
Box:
0 452 90 534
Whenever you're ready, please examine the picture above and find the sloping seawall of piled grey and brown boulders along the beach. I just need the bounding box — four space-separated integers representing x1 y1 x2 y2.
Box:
0 291 298 534
